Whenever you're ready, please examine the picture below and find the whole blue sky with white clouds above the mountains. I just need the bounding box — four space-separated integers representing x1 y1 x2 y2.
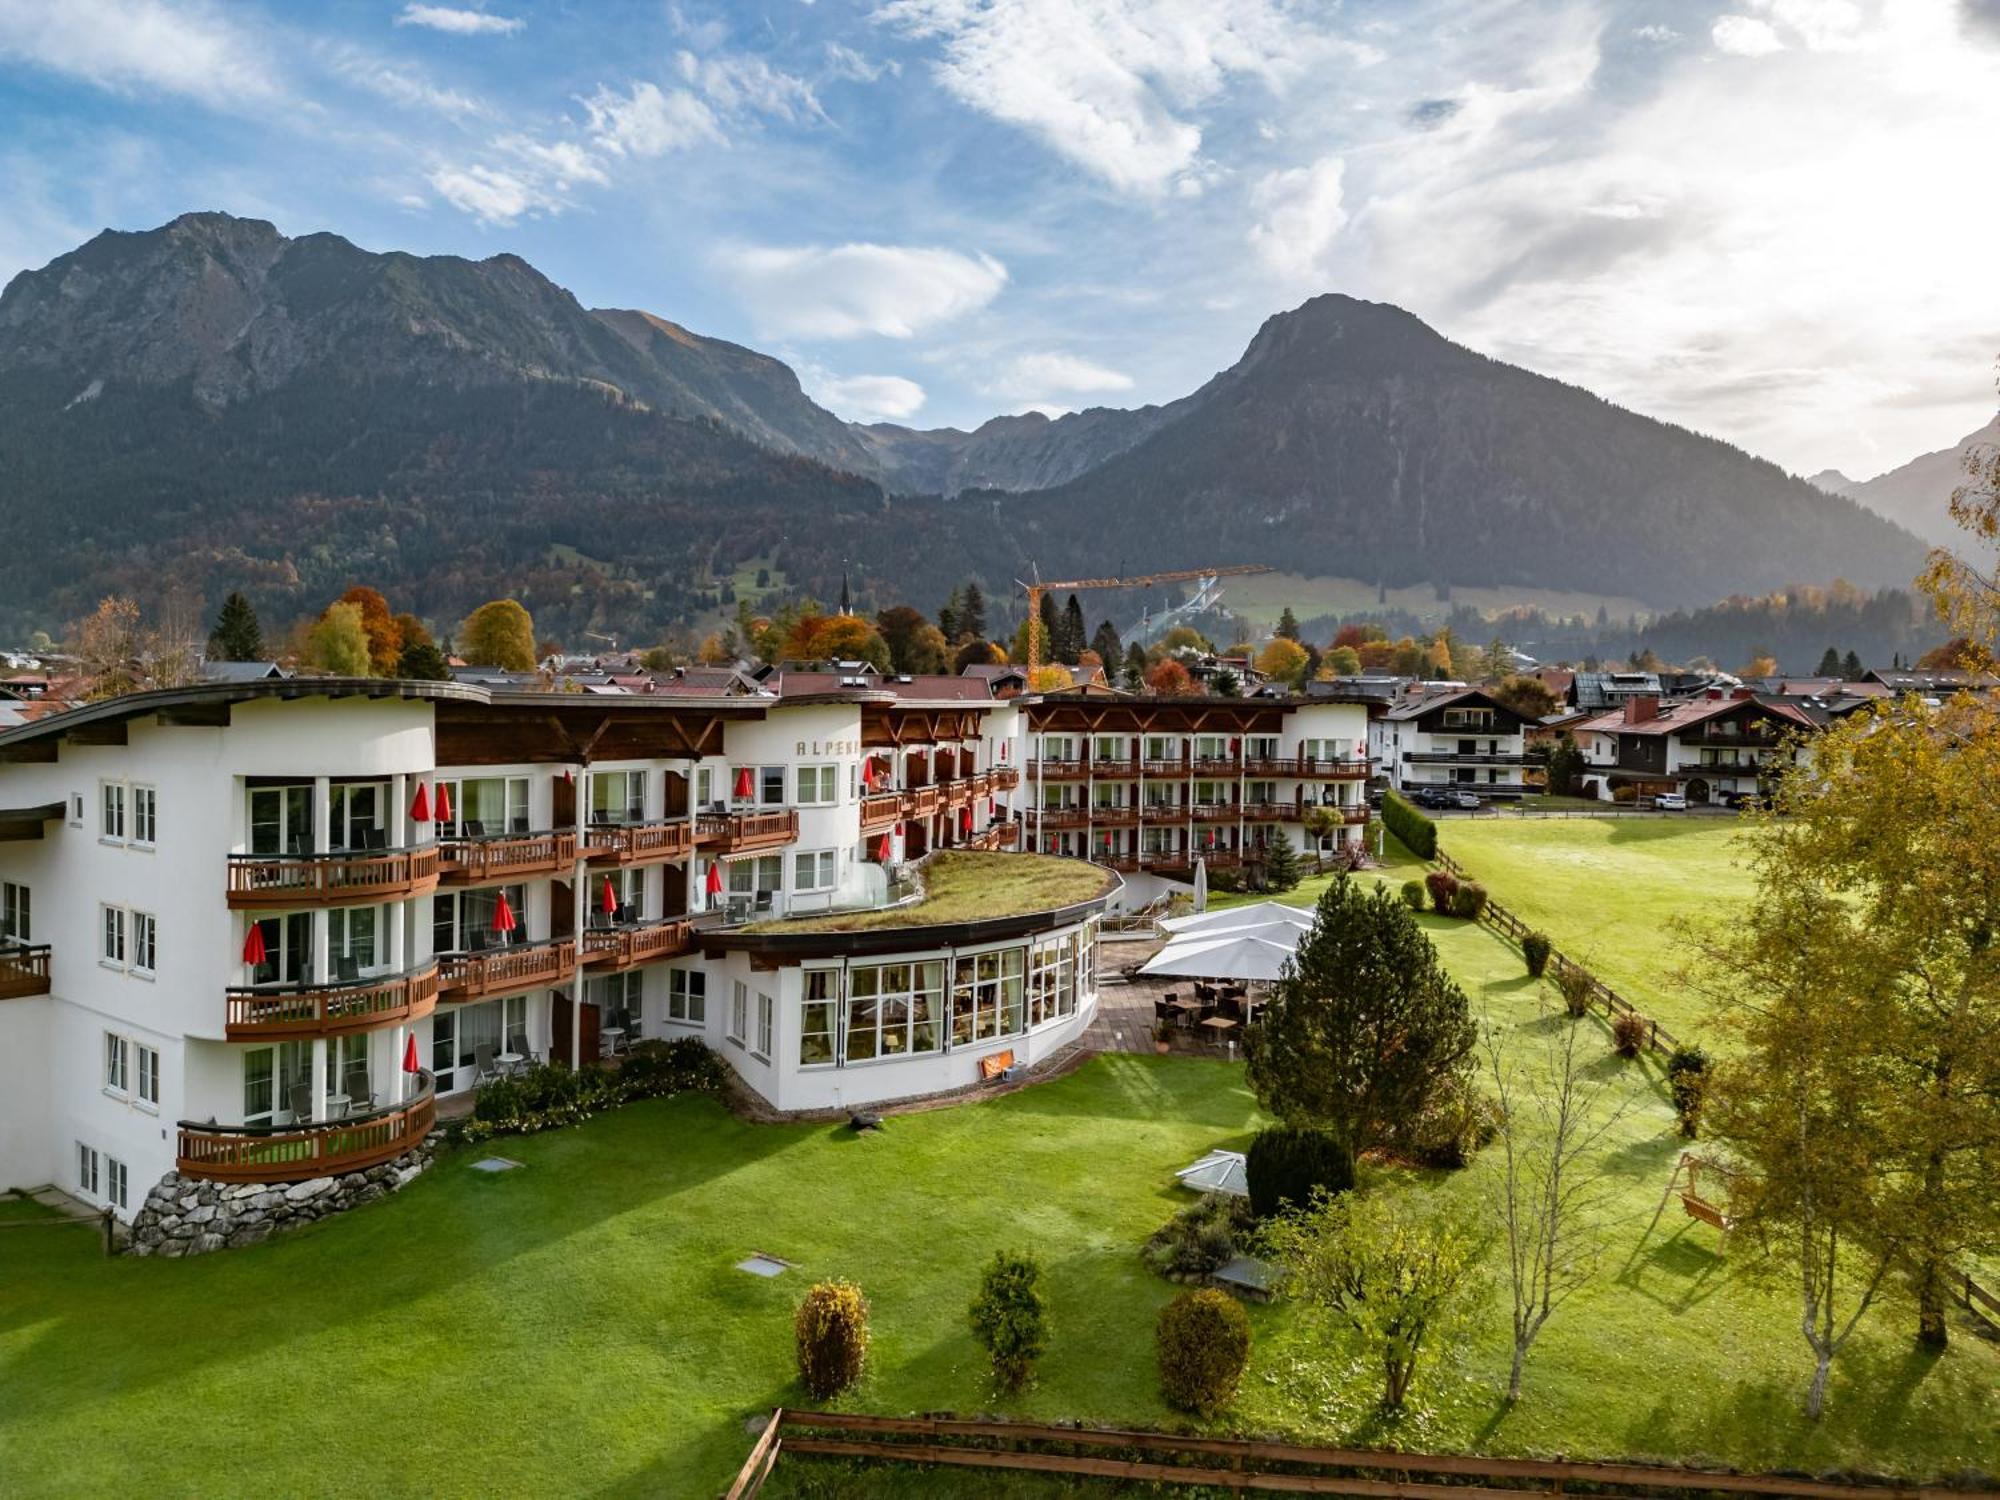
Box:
0 0 2000 476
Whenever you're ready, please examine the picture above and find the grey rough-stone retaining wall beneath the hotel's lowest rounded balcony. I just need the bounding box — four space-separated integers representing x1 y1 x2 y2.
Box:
126 1138 436 1256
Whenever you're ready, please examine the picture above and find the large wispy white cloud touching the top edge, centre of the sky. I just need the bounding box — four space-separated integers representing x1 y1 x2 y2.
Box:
874 0 1376 196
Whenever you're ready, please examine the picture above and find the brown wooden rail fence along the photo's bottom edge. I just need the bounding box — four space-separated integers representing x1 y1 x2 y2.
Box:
726 1408 2000 1500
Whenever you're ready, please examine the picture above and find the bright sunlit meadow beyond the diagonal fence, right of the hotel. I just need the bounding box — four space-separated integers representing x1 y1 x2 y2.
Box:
1438 818 1750 1038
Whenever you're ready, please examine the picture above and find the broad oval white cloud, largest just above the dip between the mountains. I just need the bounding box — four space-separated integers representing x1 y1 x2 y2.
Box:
718 244 1006 338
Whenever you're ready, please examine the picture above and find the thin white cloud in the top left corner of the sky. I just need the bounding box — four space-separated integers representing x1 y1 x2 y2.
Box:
0 0 284 110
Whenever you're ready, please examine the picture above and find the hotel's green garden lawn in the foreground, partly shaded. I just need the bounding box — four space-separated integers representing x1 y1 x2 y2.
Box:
0 918 2000 1496
